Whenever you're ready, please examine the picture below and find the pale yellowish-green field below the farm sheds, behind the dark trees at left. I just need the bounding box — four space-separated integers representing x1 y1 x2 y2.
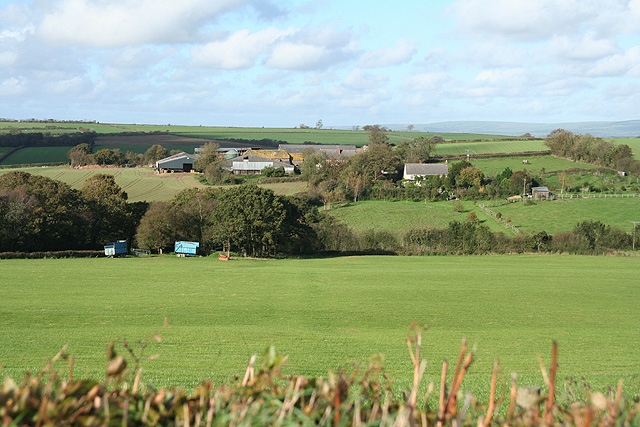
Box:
0 166 306 202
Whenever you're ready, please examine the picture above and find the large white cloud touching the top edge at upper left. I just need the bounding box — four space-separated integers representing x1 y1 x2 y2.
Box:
38 0 248 48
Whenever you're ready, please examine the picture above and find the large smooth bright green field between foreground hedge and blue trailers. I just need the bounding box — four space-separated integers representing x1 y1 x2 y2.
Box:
0 255 640 398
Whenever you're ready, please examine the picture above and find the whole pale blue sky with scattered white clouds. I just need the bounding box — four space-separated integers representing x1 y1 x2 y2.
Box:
0 0 640 127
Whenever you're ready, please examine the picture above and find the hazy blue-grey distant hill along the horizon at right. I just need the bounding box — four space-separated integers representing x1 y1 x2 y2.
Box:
372 120 640 138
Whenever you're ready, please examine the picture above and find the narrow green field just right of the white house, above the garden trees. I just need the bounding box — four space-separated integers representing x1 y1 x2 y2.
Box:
471 156 597 176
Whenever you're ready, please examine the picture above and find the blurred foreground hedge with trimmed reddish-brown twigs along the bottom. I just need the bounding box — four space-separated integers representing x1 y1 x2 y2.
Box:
0 325 640 427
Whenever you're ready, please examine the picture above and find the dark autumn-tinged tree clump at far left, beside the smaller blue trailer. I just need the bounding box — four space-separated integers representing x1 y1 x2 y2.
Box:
0 171 147 252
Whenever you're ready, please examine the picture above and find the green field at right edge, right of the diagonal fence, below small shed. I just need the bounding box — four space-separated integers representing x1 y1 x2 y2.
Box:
488 197 640 233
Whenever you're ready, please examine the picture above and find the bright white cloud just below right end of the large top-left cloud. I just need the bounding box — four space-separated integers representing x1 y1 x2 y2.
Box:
191 27 293 70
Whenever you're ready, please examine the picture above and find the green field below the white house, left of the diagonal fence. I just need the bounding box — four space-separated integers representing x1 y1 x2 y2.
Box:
327 200 505 237
